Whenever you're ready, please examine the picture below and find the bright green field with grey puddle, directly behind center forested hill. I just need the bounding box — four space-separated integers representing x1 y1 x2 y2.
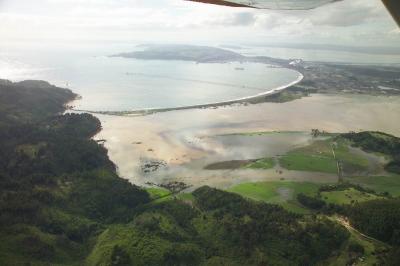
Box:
228 181 319 213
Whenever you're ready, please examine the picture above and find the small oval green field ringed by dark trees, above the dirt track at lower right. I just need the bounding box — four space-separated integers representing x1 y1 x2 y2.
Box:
321 188 379 205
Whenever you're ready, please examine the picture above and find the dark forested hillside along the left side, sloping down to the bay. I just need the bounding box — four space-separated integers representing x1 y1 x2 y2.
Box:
0 81 149 265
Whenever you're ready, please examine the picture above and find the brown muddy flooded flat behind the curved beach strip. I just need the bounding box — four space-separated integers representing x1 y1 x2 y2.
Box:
92 94 400 187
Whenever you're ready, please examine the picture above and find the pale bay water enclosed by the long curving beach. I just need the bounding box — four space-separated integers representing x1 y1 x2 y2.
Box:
0 46 299 111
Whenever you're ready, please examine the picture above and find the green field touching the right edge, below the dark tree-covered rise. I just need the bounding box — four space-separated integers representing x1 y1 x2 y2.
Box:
345 175 400 197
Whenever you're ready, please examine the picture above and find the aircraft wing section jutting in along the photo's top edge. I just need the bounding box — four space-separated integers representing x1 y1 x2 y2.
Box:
189 0 342 10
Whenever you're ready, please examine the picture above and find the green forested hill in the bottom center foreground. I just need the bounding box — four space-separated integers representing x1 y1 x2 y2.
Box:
88 187 349 265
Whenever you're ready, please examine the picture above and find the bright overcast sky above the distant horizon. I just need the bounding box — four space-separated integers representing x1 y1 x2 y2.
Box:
0 0 400 47
